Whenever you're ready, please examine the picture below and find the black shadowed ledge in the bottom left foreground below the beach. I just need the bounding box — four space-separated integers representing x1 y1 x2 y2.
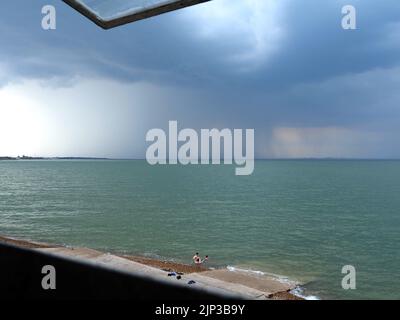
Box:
0 244 227 300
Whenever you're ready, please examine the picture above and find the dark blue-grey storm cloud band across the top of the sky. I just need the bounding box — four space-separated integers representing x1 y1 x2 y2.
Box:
0 0 400 87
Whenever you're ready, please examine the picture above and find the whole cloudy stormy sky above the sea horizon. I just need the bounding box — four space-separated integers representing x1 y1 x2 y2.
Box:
0 0 400 158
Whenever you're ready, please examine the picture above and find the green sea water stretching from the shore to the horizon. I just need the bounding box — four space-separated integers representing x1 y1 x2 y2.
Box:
0 160 400 299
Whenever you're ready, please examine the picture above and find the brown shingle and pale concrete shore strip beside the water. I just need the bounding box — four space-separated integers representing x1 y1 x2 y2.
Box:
0 236 303 300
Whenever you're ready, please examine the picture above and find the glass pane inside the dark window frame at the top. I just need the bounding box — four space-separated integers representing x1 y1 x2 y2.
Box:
77 0 177 21
